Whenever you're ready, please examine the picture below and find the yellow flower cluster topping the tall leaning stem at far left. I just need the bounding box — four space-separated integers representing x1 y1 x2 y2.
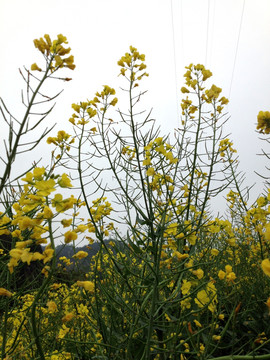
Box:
31 34 76 72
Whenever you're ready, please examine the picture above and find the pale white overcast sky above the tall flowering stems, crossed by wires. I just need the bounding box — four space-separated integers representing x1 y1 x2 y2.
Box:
0 0 270 217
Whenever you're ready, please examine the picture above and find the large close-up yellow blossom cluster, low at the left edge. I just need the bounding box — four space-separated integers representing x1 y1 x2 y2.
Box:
1 167 77 273
